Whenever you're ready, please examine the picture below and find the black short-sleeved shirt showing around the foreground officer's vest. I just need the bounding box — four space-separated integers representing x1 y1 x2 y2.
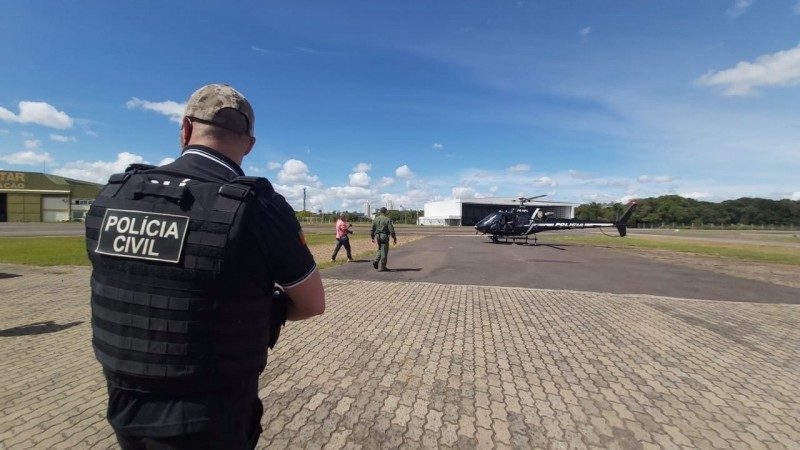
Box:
106 146 316 437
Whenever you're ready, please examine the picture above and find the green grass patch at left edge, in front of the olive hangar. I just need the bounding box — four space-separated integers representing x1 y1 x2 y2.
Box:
0 236 89 266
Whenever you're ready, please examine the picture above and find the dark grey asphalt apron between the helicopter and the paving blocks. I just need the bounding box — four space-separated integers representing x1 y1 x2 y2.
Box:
325 235 800 304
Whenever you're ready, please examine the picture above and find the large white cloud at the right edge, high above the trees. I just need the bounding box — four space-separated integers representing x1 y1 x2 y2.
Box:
697 44 800 96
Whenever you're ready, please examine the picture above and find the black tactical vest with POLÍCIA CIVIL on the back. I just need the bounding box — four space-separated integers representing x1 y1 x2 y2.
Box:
86 165 275 391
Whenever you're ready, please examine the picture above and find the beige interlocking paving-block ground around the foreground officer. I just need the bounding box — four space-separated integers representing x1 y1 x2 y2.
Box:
0 265 800 449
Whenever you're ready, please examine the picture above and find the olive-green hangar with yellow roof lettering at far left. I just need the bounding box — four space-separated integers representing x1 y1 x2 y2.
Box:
0 170 103 222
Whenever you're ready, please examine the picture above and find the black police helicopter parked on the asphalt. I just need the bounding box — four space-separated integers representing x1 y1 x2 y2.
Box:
475 195 636 245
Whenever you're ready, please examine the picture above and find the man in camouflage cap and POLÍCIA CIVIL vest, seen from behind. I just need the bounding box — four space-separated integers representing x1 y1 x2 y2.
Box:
86 84 325 449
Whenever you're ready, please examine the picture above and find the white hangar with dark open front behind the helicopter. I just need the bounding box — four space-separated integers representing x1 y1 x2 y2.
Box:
417 197 577 226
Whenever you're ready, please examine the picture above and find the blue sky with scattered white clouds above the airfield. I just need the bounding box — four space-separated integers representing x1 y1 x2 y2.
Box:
0 0 800 210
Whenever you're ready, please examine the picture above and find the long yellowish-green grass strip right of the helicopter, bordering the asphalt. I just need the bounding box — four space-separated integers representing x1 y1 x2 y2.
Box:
548 236 800 266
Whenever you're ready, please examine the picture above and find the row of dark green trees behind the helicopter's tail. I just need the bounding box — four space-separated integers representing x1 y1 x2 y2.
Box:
575 195 800 226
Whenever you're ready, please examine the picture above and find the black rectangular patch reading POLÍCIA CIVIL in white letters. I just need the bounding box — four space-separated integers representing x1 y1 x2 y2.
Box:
95 209 189 263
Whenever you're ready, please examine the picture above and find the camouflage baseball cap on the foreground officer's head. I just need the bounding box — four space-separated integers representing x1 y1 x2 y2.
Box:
183 84 255 136
